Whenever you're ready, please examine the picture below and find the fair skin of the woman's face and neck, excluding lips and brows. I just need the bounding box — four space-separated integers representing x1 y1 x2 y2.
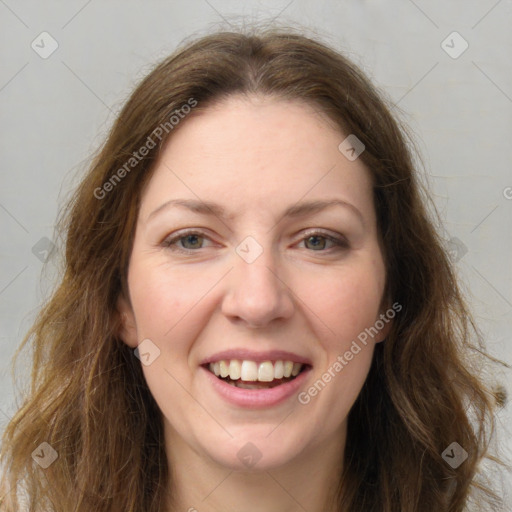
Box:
118 96 390 512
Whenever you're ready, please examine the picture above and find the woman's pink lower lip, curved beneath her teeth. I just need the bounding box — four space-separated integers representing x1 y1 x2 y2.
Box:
201 367 310 409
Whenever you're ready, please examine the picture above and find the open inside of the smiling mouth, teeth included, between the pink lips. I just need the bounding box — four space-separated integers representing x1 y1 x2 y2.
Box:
204 359 310 389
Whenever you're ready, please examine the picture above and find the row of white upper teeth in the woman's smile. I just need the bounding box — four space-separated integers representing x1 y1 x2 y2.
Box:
209 359 302 382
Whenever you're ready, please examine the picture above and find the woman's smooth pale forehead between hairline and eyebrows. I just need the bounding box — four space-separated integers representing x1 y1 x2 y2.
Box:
141 96 372 222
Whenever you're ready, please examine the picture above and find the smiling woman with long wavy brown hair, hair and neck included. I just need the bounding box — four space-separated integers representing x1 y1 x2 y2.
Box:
2 27 504 512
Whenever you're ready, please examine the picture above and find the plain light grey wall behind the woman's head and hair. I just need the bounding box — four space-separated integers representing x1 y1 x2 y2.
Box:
0 0 512 504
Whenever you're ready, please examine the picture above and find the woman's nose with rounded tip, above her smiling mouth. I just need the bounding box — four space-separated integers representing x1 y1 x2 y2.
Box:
222 250 294 328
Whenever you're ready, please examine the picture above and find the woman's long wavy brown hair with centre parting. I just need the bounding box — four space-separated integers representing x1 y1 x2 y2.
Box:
2 29 504 512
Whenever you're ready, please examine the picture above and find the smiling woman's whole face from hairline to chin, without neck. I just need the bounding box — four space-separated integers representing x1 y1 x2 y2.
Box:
119 96 389 469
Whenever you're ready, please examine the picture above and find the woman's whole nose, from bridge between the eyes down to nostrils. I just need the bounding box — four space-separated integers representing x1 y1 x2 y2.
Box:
223 237 293 325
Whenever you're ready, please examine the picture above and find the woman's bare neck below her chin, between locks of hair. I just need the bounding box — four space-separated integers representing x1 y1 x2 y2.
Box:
166 429 346 512
